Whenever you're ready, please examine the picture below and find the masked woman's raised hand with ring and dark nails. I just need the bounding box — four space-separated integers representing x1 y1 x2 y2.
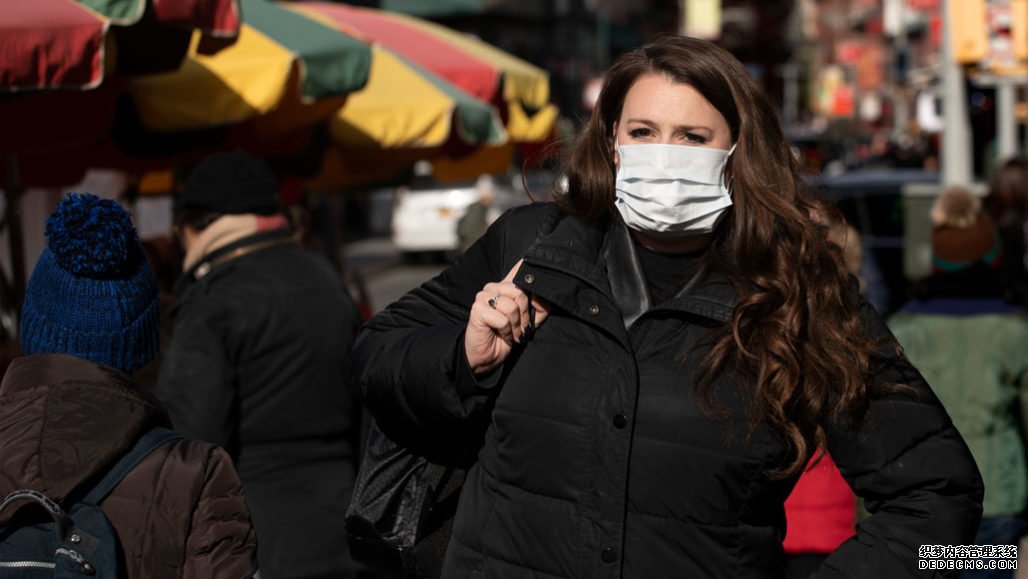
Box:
464 259 549 374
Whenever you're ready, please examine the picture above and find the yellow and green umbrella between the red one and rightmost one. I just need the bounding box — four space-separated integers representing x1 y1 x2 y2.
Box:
0 0 372 185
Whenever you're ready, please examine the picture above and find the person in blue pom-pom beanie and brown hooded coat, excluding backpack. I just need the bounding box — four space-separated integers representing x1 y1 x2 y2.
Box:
0 195 257 579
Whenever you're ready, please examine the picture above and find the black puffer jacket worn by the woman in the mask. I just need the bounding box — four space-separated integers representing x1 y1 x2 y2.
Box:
355 201 982 579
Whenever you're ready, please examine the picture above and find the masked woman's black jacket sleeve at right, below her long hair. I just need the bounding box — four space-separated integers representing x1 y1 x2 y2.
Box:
814 303 983 579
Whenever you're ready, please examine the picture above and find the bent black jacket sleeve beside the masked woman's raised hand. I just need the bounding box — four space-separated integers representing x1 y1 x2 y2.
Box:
353 210 520 429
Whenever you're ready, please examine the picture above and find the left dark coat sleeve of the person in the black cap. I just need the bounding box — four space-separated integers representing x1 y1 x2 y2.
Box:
157 295 236 448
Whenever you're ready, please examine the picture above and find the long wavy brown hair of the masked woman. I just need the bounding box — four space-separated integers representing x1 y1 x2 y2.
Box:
557 36 888 476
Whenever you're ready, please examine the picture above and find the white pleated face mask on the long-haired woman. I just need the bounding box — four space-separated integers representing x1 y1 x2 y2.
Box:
614 143 735 234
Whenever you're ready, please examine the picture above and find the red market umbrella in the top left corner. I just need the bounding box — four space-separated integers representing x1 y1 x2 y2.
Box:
0 0 240 308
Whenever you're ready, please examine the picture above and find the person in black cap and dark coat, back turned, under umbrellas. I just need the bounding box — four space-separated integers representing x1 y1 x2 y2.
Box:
158 151 361 579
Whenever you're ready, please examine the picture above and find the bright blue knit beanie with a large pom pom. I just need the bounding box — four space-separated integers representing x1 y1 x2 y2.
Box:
21 193 160 372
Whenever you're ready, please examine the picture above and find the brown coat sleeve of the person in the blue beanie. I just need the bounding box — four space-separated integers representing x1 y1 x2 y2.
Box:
182 447 257 579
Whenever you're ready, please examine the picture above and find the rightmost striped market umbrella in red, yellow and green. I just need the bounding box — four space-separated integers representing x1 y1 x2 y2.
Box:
281 1 557 188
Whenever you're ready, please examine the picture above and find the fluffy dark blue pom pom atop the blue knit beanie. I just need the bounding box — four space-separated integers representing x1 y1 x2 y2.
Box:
46 193 139 279
